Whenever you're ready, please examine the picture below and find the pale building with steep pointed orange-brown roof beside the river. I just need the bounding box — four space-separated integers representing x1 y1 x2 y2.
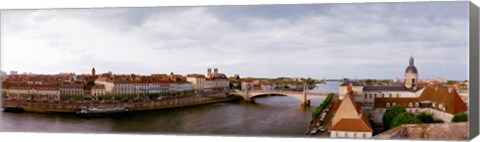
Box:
330 85 373 138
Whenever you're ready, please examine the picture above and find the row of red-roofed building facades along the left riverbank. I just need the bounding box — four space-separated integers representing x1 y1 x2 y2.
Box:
2 68 229 98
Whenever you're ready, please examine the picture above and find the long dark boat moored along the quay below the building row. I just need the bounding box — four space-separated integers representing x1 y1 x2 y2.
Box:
77 108 130 117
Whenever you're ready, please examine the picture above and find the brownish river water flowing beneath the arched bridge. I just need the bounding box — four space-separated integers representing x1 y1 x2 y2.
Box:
0 82 340 136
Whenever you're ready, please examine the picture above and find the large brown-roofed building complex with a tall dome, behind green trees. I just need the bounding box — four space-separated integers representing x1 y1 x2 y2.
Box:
339 57 468 124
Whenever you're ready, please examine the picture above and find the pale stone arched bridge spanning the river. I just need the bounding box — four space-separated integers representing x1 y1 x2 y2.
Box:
229 84 328 106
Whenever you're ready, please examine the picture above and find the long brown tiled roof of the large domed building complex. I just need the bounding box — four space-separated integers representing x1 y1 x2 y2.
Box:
374 86 468 114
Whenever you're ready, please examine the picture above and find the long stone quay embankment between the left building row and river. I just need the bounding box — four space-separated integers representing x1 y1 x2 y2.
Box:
2 93 238 113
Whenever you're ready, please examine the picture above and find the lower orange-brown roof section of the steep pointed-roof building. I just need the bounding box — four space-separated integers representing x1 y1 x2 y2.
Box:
332 118 373 132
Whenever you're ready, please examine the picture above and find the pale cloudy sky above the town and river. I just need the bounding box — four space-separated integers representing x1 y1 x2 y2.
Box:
0 2 468 80
